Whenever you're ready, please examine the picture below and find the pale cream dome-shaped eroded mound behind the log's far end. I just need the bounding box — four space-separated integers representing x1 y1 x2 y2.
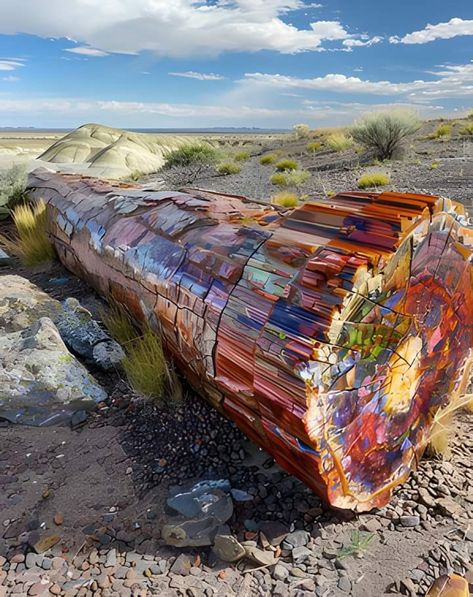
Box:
38 124 206 178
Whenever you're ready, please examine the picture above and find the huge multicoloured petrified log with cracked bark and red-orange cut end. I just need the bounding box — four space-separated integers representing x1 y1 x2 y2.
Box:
29 171 473 511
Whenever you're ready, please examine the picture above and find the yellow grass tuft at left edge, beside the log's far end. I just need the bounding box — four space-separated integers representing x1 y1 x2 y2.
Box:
0 200 55 267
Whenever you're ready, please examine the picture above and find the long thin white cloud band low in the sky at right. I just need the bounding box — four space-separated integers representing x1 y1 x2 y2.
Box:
239 62 473 102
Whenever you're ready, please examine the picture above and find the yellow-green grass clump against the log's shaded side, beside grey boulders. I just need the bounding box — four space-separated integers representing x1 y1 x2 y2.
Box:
101 304 180 402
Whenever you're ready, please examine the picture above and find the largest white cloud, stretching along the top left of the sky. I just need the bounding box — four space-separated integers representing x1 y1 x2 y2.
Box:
0 0 376 57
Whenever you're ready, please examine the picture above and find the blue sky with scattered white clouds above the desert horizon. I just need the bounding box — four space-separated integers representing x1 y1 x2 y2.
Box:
0 0 473 128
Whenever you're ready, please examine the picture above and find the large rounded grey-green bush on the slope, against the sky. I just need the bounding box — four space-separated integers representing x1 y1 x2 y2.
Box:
351 111 421 161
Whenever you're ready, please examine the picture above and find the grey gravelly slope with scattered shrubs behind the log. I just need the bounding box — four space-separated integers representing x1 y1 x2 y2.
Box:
147 121 473 208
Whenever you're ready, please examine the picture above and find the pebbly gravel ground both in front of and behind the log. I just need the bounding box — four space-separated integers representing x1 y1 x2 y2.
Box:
0 118 473 597
